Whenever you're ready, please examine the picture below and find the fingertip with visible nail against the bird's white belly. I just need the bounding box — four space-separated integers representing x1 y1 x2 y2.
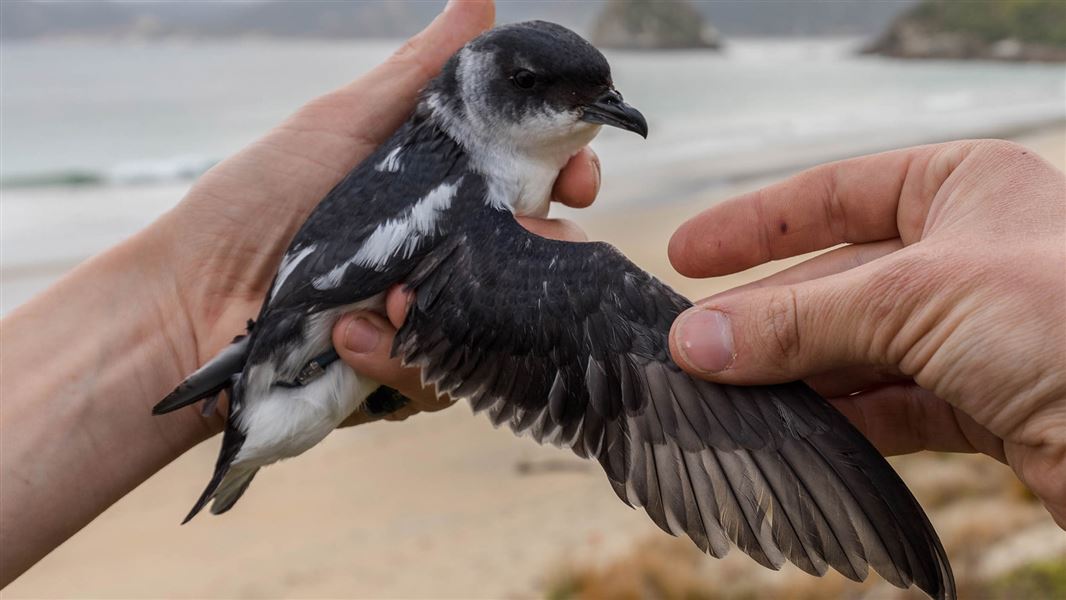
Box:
333 312 436 403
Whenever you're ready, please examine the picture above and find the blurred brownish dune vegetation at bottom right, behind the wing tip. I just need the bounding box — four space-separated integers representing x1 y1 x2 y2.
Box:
543 454 1066 600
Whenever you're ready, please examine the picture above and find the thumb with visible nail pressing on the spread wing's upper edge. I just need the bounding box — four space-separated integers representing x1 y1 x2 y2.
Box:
669 267 887 385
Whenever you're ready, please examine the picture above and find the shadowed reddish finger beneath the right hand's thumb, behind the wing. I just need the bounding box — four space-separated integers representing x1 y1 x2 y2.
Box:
829 385 1006 461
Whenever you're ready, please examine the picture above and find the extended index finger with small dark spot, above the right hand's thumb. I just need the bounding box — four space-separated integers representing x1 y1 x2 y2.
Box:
669 143 968 277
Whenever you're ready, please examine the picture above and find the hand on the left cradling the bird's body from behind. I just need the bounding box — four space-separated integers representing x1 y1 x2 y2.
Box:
142 1 599 431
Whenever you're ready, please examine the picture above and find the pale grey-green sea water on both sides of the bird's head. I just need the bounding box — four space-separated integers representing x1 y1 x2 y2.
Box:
0 39 1066 311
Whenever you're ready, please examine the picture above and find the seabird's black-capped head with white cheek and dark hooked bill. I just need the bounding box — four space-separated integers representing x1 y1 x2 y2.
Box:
424 21 648 160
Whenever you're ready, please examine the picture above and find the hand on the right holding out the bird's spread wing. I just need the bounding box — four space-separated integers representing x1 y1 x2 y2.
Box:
669 141 1066 528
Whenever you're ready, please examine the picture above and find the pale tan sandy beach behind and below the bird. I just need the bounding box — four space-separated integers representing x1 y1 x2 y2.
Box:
3 124 1066 599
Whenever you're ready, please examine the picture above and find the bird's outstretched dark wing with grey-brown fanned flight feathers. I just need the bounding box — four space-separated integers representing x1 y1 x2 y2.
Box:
393 210 954 598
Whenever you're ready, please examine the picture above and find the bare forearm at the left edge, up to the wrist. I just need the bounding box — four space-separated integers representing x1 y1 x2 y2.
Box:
0 226 217 585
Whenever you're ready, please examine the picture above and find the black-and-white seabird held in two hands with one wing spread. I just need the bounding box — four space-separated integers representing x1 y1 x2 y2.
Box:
154 21 955 599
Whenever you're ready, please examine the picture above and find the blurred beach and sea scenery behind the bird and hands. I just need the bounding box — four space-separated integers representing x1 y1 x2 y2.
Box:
0 0 1066 598
